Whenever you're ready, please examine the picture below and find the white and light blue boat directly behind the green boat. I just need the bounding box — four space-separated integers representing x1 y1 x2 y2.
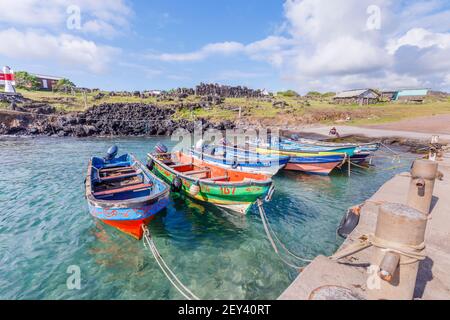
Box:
189 146 289 176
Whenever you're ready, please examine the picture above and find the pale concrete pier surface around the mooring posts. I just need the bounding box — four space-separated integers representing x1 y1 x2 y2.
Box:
279 153 450 300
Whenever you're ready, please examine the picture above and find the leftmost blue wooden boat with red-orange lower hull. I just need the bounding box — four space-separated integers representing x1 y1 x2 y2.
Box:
86 148 170 239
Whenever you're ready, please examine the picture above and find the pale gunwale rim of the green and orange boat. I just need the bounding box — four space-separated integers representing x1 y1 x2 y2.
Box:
147 152 273 187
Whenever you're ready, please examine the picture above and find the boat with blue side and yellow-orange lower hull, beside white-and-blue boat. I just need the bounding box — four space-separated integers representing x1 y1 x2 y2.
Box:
256 148 349 175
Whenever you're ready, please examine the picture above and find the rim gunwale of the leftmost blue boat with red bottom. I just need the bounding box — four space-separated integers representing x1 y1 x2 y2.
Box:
85 153 170 209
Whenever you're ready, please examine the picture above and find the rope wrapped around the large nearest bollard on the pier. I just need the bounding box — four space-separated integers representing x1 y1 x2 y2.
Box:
330 234 426 265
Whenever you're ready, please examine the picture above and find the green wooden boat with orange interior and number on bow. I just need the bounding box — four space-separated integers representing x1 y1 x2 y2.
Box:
147 151 274 214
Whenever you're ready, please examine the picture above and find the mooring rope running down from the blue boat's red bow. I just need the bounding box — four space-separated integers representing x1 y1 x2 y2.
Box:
142 225 200 300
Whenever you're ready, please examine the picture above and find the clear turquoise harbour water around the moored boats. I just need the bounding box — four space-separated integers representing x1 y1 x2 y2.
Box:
0 138 411 299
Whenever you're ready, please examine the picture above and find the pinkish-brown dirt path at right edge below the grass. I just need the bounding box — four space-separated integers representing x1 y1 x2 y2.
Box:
368 114 450 134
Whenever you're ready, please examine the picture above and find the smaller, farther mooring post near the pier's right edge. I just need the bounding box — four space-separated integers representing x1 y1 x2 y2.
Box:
407 160 438 214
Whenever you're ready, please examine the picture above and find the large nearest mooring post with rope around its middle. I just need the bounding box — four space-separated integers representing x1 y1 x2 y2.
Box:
367 203 428 300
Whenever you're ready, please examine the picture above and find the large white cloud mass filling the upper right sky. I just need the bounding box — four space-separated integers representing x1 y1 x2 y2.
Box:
145 0 450 91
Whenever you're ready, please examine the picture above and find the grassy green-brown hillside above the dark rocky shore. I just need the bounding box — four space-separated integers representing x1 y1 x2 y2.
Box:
15 90 450 125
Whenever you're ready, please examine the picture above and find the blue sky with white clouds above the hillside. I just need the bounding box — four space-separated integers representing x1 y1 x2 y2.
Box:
0 0 450 93
